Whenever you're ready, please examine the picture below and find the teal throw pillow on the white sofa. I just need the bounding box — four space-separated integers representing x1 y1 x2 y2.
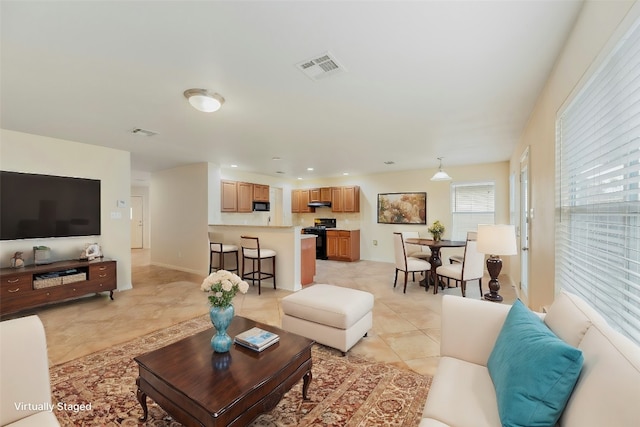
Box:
488 300 583 427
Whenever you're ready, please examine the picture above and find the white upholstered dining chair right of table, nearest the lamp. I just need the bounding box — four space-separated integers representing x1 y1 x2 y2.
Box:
436 231 484 297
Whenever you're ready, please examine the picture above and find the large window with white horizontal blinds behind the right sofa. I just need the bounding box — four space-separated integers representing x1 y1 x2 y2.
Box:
555 16 640 344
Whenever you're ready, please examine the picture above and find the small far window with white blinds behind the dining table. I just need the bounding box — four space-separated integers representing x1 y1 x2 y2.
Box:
451 182 495 240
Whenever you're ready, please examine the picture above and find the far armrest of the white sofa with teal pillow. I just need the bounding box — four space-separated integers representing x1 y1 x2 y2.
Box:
440 295 511 366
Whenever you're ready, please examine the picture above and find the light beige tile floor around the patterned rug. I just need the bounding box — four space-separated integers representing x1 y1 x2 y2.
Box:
33 250 516 375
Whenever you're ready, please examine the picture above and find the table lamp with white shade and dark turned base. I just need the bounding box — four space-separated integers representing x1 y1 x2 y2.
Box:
477 224 518 302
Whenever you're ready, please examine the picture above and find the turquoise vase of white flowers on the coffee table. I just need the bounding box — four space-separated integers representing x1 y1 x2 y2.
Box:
200 270 249 353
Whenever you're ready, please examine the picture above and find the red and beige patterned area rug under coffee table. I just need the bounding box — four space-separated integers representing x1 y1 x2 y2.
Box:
51 316 431 427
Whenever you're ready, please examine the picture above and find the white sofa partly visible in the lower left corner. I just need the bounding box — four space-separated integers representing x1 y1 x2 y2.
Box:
0 316 60 427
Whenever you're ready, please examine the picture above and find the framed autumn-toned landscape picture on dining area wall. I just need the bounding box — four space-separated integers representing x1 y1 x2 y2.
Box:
378 193 427 225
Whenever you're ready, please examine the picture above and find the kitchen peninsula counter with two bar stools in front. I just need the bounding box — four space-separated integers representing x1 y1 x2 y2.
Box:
209 224 308 291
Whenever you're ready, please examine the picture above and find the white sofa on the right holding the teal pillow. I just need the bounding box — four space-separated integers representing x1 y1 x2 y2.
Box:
420 293 640 427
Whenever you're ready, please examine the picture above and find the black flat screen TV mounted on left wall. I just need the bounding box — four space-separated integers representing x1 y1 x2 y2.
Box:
0 171 100 240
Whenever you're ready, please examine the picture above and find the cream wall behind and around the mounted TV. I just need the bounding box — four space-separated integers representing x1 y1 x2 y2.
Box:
0 129 131 290
